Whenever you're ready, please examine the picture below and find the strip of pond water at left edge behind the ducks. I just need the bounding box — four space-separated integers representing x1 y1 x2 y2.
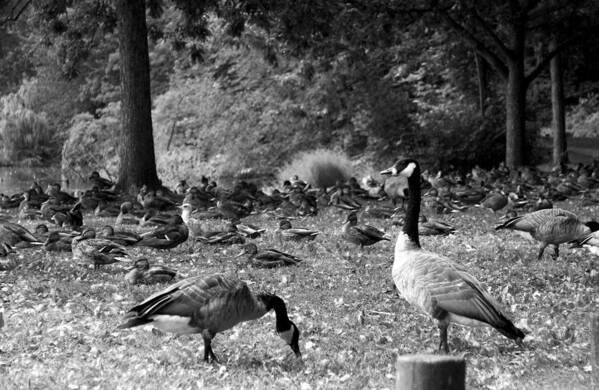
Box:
0 166 82 195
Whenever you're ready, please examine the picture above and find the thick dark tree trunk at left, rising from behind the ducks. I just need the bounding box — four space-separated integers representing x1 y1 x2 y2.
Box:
116 0 160 191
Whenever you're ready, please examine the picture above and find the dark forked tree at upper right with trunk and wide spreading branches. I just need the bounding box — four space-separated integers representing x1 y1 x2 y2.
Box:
425 0 599 167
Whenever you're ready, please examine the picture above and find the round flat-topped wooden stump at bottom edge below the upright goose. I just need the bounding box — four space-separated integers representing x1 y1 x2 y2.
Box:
395 355 466 390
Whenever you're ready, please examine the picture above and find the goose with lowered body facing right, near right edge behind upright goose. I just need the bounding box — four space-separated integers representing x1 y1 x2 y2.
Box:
495 209 599 260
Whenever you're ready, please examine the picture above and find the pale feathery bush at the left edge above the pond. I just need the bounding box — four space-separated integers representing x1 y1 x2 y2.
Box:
0 93 58 165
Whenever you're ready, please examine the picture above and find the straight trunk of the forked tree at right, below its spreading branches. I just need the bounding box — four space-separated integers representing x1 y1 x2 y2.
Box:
505 22 526 168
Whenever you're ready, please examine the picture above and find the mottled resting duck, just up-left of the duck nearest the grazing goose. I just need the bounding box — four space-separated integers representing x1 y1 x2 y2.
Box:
71 227 129 269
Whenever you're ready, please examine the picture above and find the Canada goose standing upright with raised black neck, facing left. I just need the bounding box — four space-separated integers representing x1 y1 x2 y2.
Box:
381 159 524 352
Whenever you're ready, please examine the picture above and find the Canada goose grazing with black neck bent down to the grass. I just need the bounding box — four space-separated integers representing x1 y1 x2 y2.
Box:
119 275 301 362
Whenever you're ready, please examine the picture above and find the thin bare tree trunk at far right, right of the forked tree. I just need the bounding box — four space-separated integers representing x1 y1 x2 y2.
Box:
549 36 568 166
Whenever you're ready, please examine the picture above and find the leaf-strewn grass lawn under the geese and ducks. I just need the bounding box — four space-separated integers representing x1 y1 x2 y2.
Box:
0 200 599 390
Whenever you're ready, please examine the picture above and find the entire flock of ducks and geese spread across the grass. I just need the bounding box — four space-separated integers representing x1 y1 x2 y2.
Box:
0 159 599 362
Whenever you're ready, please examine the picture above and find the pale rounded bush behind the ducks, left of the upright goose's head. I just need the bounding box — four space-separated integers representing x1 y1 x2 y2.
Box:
278 149 353 188
